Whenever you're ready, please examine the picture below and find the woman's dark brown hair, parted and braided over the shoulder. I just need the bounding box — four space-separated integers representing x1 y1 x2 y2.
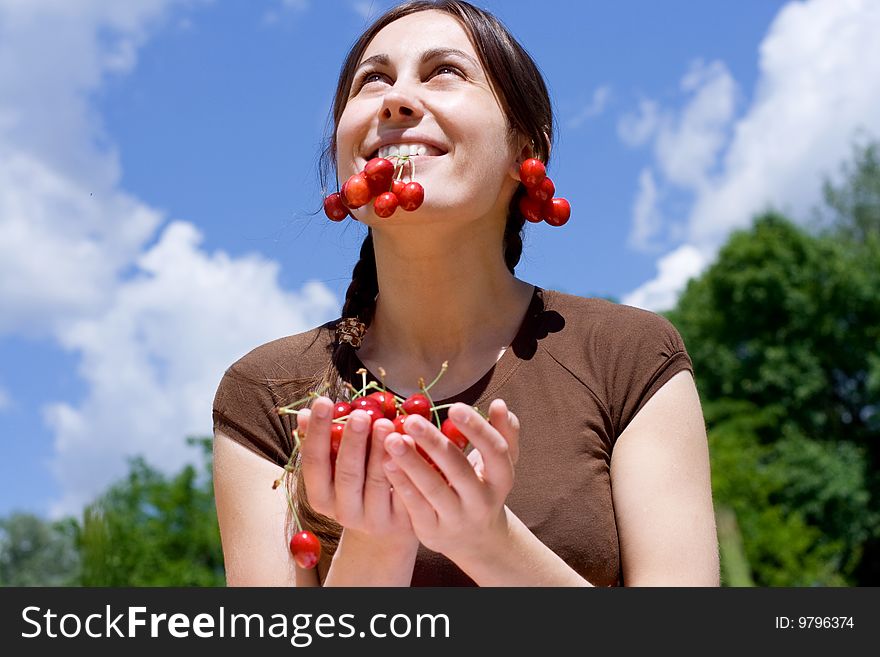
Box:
294 0 553 568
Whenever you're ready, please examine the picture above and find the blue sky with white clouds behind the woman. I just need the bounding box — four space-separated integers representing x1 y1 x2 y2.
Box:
0 0 880 515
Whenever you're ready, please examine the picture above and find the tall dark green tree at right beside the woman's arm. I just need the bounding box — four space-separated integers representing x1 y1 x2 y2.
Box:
668 206 880 586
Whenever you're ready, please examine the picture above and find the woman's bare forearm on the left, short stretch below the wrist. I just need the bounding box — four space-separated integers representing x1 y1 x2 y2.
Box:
324 530 419 586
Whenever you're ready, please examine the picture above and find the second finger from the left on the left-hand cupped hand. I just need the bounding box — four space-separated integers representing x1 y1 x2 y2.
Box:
334 410 370 525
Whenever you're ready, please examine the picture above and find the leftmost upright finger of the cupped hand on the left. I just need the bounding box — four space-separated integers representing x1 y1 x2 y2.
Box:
297 397 334 514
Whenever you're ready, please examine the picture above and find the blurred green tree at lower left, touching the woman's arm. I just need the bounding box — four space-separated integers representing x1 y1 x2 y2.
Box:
77 439 225 586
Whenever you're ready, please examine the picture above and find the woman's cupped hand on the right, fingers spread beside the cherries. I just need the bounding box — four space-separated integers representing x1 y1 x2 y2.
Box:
384 399 519 561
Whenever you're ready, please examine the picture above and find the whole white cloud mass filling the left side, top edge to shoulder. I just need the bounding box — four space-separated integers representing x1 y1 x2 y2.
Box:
0 0 338 515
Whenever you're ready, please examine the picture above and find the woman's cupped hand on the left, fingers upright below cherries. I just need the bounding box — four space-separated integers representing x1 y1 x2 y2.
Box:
297 397 418 547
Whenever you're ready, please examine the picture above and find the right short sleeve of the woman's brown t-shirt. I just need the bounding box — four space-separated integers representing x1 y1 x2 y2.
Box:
610 309 694 440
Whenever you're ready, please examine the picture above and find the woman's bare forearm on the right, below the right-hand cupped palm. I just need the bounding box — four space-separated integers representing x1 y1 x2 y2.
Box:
447 506 593 586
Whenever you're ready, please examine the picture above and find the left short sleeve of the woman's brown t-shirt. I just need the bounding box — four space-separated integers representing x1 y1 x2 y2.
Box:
213 363 291 466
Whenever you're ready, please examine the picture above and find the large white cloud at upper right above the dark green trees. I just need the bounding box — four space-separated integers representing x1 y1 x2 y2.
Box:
619 0 880 310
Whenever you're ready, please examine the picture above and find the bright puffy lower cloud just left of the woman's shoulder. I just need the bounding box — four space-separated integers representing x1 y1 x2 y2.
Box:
46 222 338 514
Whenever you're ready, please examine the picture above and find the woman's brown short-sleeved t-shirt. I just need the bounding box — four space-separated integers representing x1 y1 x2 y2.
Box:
214 287 693 586
